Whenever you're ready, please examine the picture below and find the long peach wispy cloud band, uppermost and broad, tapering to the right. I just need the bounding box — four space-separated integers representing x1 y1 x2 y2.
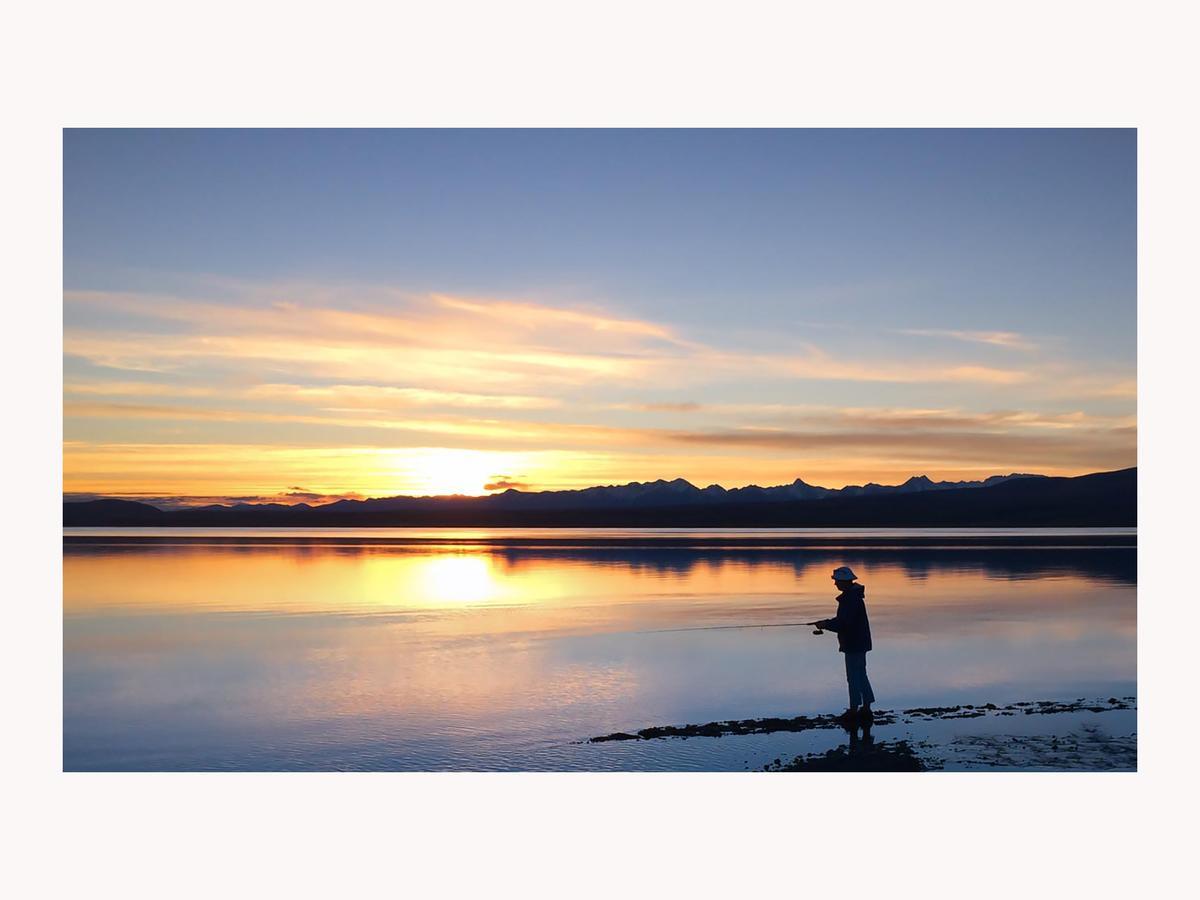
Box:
65 288 1030 391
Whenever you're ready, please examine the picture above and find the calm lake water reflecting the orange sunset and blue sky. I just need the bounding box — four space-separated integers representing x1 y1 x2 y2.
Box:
64 529 1136 770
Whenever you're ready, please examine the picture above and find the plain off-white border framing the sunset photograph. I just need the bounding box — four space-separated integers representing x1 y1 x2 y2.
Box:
0 0 1200 898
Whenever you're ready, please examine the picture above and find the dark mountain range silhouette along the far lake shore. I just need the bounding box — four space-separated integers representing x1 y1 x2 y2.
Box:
62 468 1138 528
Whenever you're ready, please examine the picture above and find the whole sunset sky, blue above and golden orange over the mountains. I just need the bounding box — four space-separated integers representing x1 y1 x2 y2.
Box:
64 131 1136 503
